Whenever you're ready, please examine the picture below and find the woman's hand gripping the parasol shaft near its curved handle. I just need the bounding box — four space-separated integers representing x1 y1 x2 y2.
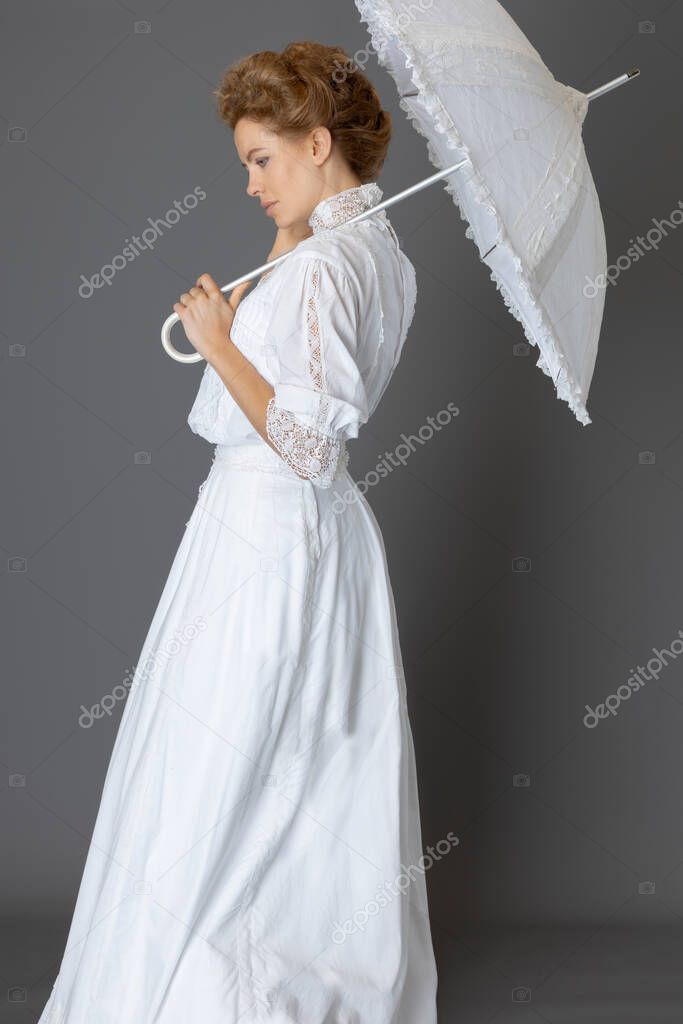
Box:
173 273 251 362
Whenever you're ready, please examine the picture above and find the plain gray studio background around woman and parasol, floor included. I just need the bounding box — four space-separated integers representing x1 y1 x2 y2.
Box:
0 0 683 1024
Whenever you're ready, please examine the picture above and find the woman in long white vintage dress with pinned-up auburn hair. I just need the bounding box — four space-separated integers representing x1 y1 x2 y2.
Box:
39 43 436 1024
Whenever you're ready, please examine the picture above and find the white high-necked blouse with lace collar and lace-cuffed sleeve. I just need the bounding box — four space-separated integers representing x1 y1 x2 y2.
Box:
187 182 417 487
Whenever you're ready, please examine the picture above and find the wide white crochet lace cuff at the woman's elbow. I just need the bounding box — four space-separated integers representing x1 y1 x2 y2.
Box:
265 396 348 487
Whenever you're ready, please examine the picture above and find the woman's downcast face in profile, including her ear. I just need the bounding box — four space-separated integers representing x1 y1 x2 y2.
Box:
233 118 329 227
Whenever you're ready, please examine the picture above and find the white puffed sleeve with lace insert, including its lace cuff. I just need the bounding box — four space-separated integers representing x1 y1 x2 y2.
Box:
266 254 368 487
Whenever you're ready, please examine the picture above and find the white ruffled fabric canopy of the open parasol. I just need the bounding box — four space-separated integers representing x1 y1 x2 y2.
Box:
355 0 607 425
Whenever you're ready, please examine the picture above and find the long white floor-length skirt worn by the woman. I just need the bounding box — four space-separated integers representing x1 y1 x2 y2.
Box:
39 441 436 1024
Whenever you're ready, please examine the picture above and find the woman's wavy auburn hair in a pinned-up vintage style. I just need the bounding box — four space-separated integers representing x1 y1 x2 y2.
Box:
214 42 392 183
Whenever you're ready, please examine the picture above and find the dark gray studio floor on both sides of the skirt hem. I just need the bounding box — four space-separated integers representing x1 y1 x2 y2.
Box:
5 922 683 1024
